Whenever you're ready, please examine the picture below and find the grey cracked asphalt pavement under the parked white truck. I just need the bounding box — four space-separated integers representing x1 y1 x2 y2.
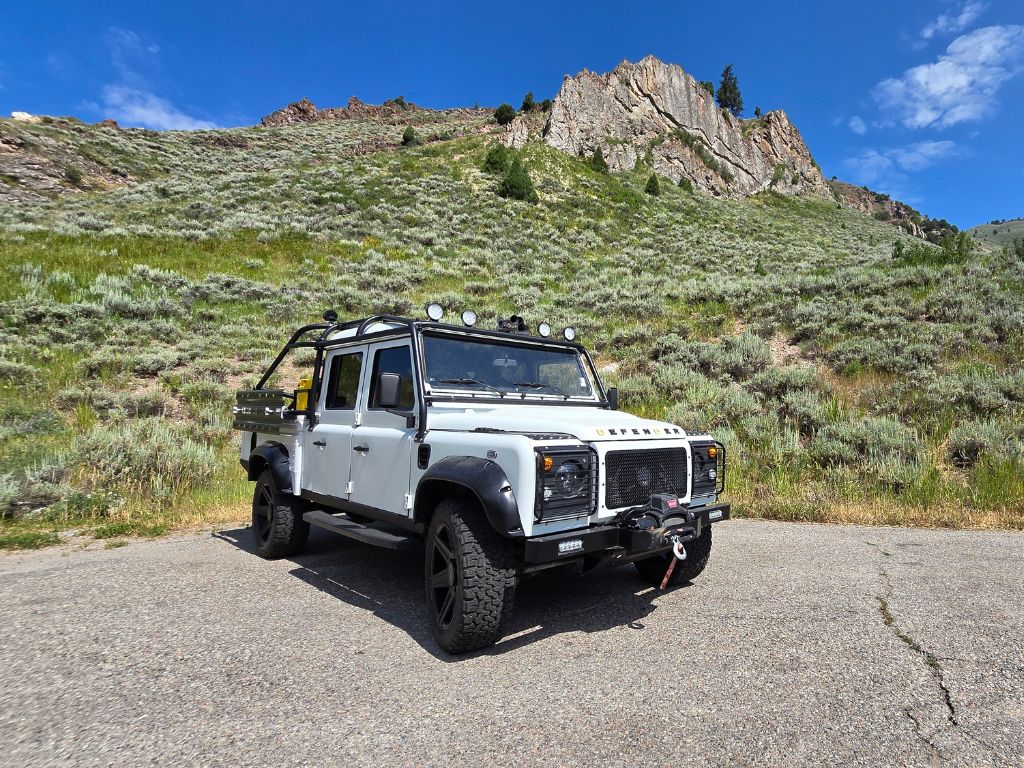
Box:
0 520 1024 767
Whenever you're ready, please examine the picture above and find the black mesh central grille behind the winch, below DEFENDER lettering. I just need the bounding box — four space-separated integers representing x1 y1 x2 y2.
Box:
604 447 686 509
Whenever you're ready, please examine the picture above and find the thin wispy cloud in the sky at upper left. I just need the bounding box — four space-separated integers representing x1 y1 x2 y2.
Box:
97 27 217 130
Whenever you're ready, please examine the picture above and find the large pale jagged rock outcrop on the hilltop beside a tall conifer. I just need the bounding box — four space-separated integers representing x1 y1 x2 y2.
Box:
544 56 828 197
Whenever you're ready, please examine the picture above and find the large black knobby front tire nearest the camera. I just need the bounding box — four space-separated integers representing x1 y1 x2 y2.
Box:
424 499 516 653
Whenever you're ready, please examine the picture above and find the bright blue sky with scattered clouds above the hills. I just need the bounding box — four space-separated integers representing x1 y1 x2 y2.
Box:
0 0 1024 226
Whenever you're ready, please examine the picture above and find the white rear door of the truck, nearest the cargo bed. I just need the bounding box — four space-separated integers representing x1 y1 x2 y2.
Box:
302 347 367 500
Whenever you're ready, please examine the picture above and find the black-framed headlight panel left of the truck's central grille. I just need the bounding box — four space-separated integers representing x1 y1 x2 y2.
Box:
537 446 597 522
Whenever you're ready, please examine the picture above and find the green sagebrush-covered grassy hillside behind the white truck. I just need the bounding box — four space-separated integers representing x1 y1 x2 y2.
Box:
0 115 1024 547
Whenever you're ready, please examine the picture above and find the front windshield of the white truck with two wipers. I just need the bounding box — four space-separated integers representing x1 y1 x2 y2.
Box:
423 335 594 400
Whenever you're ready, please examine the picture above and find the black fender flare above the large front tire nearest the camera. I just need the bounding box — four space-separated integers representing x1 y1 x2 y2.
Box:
413 456 523 538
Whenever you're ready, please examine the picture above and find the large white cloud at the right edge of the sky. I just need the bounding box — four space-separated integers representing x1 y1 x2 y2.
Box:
873 25 1024 128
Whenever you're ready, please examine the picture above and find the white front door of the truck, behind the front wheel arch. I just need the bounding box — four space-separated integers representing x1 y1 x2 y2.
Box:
351 340 417 516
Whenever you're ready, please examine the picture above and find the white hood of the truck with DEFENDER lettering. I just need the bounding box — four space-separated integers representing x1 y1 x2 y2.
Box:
427 403 686 442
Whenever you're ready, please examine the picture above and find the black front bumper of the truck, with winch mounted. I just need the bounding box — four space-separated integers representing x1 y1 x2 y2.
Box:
523 504 730 564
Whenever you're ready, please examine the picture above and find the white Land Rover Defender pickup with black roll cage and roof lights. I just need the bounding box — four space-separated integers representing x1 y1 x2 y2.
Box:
234 304 729 653
